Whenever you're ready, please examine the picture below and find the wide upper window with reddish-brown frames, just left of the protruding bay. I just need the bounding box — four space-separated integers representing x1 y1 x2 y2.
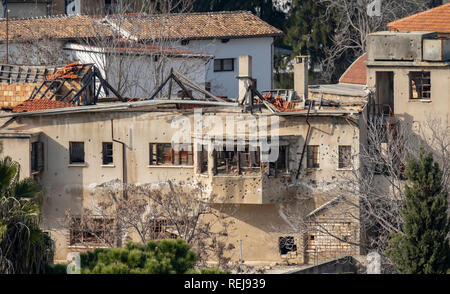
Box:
149 143 194 166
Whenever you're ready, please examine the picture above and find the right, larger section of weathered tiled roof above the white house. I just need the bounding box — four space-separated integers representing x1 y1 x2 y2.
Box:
107 11 283 39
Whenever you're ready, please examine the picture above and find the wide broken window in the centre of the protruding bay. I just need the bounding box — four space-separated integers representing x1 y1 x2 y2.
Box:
214 146 261 174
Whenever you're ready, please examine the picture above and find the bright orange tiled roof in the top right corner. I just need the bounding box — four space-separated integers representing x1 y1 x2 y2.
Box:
387 3 450 33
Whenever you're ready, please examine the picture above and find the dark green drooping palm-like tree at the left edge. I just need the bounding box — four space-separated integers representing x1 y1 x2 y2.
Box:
0 142 53 274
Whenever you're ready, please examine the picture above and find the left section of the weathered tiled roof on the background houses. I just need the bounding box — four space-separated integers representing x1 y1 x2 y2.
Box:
0 16 117 41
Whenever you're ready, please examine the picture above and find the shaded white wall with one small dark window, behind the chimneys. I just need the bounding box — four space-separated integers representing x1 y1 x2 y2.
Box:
178 38 274 98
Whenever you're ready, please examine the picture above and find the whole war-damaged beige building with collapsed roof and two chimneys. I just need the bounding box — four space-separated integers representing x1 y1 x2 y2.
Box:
0 56 368 264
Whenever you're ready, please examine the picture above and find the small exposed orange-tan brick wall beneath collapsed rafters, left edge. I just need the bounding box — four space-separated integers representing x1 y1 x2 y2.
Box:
0 83 41 107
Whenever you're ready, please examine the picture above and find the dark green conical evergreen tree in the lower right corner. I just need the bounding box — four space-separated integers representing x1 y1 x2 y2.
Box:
388 150 450 274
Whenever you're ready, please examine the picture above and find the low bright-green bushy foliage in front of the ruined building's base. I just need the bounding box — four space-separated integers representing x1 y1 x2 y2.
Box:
81 239 197 274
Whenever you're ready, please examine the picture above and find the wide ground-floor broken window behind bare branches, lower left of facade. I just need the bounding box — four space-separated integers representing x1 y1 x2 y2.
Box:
69 217 114 246
